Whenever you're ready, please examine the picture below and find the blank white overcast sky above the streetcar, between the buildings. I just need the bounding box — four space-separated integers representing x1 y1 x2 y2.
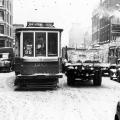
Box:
13 0 100 46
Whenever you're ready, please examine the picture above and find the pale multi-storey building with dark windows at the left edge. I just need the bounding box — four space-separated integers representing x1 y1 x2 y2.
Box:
0 0 13 47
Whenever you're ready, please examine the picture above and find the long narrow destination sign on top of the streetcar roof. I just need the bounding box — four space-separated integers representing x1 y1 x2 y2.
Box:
27 22 54 27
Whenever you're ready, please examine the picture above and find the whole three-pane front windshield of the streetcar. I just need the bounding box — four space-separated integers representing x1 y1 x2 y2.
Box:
23 32 58 57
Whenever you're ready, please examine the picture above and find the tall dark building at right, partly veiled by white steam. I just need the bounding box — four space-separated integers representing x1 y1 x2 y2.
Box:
92 0 120 45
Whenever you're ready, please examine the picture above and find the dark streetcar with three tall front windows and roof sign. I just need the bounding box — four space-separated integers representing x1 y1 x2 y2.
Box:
15 22 63 88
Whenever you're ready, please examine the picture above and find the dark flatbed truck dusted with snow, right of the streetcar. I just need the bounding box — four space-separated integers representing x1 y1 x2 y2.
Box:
66 60 102 86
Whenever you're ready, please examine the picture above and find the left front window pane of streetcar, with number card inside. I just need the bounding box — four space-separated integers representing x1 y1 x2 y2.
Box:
23 32 34 57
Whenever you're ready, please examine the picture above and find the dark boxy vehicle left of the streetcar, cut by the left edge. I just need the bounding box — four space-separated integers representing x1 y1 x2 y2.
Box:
0 47 14 72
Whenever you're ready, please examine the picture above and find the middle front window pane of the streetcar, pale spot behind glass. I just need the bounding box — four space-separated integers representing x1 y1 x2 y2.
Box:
35 32 46 56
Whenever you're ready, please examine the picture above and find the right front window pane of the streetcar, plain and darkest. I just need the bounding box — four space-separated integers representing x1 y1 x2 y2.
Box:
48 33 58 56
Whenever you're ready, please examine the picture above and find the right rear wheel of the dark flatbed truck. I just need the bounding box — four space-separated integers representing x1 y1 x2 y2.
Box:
93 71 102 86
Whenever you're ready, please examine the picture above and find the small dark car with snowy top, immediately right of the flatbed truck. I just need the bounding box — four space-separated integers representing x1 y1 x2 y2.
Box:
101 63 110 76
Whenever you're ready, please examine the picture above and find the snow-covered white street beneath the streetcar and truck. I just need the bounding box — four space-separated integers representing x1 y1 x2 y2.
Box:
0 72 120 120
